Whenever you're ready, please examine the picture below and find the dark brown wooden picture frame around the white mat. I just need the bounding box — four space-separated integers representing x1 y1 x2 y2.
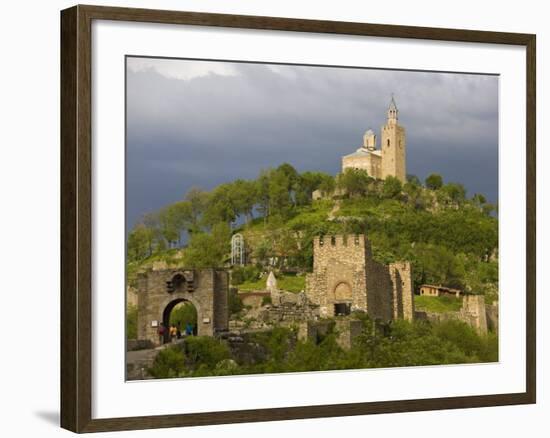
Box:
61 6 536 432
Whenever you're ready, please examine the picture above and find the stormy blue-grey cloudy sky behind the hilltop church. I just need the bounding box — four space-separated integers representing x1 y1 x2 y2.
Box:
126 58 498 228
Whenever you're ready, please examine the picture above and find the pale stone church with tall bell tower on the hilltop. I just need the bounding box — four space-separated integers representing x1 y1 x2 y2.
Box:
342 96 407 183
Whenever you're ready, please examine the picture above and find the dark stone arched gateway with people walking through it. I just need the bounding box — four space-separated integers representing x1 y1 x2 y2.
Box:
137 269 229 344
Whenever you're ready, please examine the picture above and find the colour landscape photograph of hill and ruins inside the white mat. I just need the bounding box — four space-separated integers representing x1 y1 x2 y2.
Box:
125 56 499 380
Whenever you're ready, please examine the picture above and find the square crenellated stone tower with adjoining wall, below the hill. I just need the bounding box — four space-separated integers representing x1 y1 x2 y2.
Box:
306 235 414 321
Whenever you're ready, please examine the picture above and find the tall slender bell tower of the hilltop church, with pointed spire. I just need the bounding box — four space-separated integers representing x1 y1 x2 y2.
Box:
380 96 407 183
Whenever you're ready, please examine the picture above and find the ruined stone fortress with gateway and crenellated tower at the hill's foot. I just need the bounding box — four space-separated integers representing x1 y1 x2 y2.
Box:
136 235 498 356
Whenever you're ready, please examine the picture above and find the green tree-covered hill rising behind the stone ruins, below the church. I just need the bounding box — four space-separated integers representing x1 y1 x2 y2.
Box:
128 164 498 302
